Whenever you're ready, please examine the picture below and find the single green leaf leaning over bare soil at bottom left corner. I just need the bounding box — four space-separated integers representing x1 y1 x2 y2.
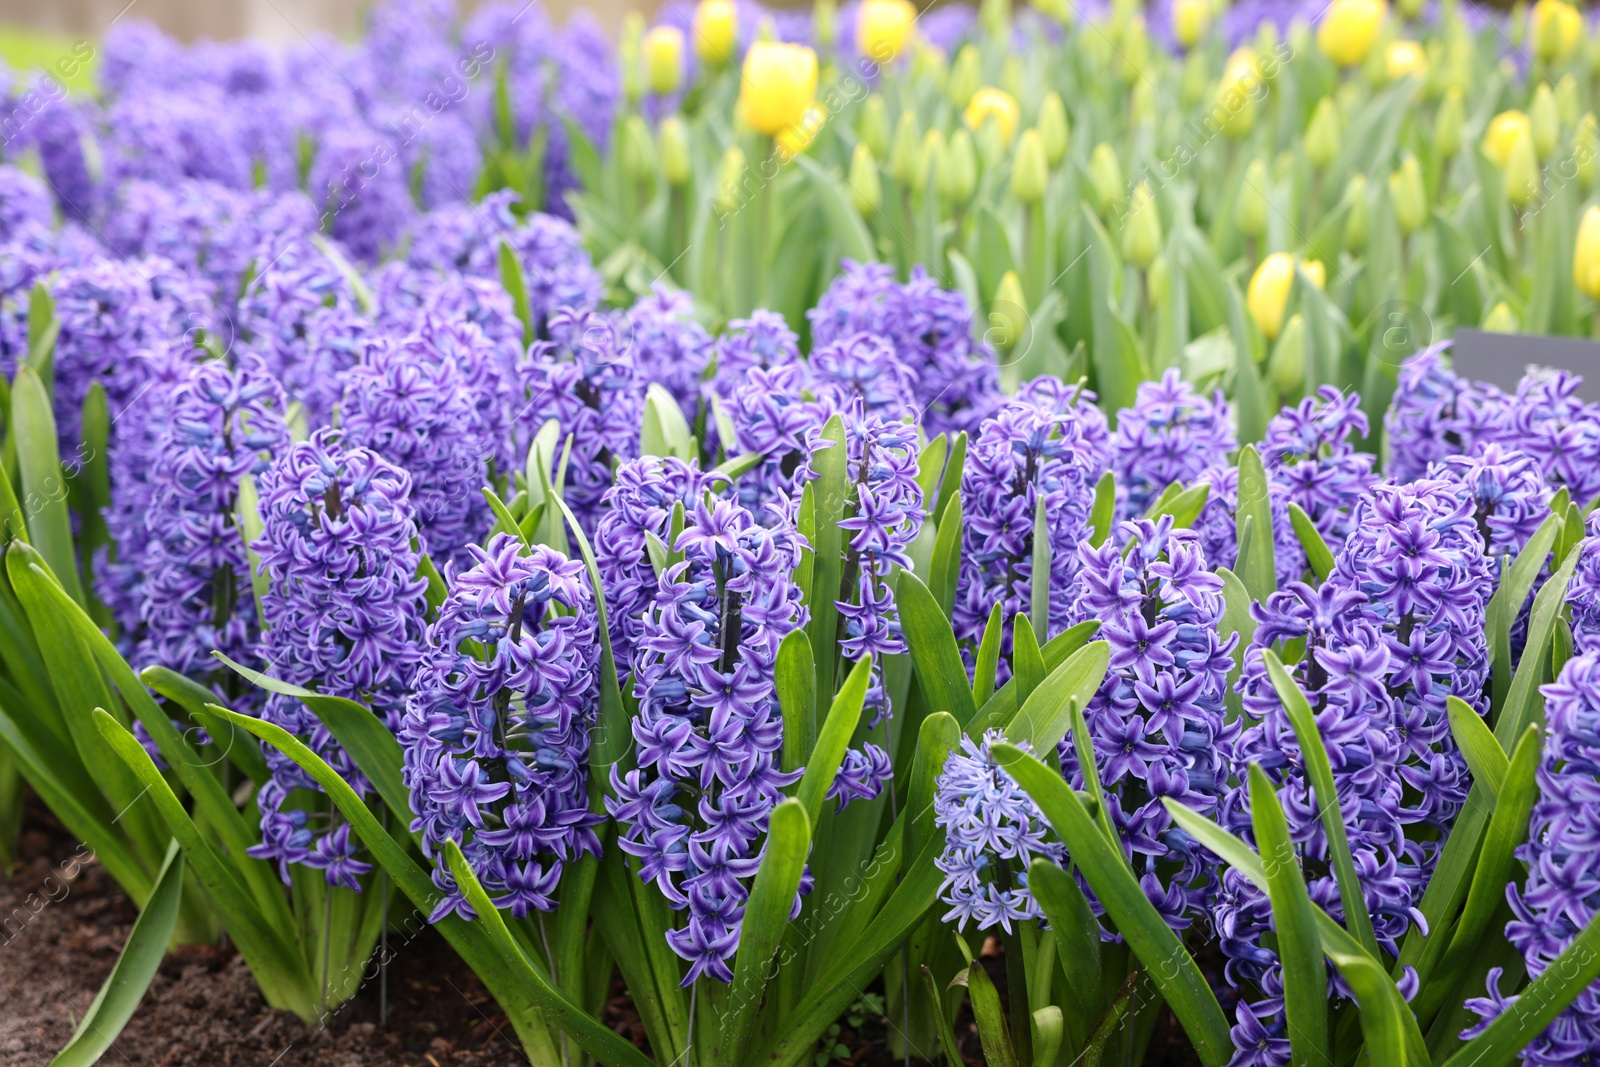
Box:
50 841 184 1067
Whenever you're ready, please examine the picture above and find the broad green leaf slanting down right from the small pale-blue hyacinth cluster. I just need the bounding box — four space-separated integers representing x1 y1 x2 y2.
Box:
994 744 1234 1064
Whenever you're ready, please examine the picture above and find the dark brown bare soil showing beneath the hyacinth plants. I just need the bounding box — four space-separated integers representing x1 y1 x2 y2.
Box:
0 803 1195 1067
